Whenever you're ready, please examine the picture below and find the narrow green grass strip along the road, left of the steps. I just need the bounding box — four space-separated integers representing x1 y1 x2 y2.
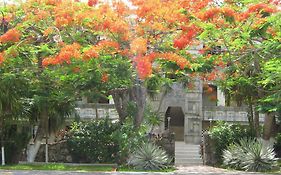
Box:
0 163 175 172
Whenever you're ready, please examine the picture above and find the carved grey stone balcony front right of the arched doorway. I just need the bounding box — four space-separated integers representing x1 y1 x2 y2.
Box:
203 106 264 122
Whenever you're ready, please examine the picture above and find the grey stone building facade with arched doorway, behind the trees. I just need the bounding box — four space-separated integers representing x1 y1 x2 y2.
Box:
77 80 264 144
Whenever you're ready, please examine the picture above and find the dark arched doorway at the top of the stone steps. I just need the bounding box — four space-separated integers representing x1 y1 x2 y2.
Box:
165 107 184 141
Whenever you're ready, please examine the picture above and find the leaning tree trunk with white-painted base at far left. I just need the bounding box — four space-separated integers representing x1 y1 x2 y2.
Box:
27 109 48 162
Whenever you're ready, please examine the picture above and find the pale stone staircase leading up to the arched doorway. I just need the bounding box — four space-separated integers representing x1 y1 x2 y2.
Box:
175 141 203 166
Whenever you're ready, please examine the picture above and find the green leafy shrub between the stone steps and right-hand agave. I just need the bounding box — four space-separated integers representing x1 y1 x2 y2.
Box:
209 122 252 163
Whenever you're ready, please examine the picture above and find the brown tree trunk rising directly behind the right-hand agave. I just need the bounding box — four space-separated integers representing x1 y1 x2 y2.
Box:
263 113 275 140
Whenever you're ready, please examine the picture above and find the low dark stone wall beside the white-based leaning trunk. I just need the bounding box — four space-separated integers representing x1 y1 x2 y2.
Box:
35 141 72 163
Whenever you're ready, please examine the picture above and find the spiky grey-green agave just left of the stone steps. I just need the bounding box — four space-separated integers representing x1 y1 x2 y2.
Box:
128 142 170 170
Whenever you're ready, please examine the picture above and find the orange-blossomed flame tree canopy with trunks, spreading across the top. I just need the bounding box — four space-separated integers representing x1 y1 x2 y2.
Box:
0 0 280 161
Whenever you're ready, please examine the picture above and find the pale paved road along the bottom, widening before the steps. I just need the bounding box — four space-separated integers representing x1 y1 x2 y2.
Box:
0 166 272 175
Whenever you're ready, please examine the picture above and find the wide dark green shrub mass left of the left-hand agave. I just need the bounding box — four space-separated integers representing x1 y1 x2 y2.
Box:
67 117 147 164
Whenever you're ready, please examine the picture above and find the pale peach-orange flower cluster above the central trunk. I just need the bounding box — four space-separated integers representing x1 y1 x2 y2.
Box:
130 37 147 55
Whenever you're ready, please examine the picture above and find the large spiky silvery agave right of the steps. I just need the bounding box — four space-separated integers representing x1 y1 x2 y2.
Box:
223 139 276 171
